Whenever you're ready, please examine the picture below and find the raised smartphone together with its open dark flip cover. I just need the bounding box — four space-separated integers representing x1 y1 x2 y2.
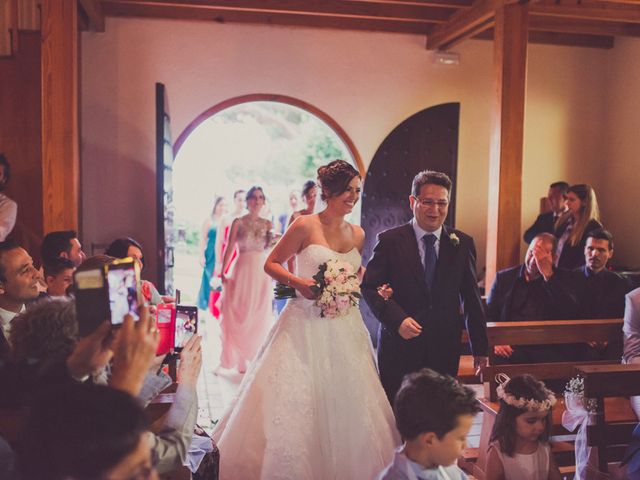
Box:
74 257 142 337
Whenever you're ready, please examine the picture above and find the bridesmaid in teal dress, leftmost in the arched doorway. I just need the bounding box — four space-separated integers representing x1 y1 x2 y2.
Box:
198 197 225 312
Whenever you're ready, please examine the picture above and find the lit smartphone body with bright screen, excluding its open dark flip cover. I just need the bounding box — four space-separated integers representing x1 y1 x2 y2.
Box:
106 257 142 325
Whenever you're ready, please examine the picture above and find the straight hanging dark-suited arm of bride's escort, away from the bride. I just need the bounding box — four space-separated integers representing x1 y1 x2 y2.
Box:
460 237 488 357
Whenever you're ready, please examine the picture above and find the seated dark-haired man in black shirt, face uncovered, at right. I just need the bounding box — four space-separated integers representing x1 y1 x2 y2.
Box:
578 229 629 318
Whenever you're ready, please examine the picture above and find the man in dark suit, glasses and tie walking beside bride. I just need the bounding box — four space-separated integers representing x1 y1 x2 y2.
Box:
362 170 487 401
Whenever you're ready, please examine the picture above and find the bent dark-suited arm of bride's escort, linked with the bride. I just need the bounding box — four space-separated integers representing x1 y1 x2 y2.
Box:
362 235 409 332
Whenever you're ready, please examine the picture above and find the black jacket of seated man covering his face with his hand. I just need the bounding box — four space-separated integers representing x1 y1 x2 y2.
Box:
487 265 581 322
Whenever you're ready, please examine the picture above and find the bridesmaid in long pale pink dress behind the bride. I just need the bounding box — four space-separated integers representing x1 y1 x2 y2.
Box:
220 187 273 373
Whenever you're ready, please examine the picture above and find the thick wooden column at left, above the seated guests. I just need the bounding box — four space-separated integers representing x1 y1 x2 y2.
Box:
41 0 80 233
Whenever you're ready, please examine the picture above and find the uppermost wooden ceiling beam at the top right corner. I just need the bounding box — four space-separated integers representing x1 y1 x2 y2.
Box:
531 3 640 23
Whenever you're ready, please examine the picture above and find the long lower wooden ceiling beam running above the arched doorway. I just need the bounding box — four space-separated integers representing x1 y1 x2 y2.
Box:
103 2 442 34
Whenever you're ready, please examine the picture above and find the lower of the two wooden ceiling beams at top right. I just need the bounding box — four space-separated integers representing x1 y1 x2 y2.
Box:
529 15 640 37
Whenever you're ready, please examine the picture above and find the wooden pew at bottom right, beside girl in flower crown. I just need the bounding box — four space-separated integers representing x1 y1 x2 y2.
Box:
577 364 640 472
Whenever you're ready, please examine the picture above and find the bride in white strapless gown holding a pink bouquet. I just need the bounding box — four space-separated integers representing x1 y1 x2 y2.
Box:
213 160 399 480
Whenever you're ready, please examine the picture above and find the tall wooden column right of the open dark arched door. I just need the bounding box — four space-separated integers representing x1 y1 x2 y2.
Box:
486 3 529 289
